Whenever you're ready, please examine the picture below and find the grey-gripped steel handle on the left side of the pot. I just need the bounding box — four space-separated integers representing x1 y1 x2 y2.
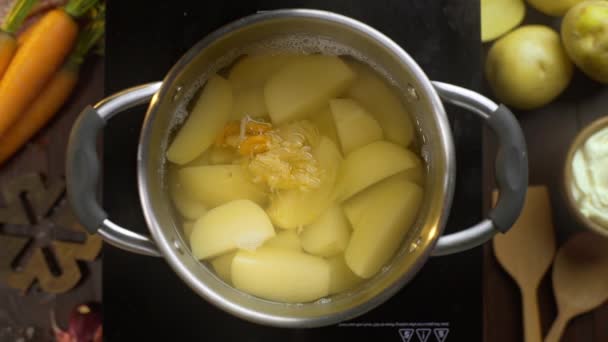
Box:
66 82 161 256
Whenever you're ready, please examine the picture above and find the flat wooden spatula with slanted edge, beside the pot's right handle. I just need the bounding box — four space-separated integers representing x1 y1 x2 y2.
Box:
494 186 556 342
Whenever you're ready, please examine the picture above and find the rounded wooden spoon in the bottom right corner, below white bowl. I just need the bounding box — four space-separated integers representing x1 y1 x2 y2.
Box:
545 232 608 342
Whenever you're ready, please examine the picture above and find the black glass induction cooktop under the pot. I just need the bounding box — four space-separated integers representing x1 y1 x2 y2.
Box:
103 0 482 342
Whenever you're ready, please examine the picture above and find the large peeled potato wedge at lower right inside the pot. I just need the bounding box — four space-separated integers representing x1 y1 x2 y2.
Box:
344 177 423 278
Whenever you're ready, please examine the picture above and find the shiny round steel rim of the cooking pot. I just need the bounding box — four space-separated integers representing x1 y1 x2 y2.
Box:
137 9 456 328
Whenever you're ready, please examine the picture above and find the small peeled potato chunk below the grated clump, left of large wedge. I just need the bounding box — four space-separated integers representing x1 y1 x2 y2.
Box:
300 206 350 257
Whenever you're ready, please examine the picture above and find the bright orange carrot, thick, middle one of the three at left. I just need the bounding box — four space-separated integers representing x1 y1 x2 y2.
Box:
0 0 97 137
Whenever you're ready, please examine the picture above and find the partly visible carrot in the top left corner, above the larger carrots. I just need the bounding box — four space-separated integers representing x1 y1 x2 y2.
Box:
0 0 37 78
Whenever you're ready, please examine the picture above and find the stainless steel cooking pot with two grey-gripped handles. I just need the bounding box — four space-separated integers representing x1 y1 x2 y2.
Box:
67 9 528 327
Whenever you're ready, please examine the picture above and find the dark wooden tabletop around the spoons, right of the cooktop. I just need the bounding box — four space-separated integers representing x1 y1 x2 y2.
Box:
483 42 608 342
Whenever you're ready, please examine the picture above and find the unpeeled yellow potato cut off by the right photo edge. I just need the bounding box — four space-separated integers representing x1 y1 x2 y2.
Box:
562 0 608 83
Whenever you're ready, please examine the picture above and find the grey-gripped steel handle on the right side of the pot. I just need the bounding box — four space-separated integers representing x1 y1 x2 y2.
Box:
432 82 528 256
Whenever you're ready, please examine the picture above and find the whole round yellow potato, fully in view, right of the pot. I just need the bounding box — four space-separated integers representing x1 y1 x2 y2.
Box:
485 25 573 109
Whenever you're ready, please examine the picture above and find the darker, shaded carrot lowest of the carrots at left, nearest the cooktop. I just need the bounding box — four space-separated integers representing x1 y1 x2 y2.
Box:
0 6 105 165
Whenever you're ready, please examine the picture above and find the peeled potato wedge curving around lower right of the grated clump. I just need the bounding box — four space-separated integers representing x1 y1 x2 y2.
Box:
267 136 342 229
